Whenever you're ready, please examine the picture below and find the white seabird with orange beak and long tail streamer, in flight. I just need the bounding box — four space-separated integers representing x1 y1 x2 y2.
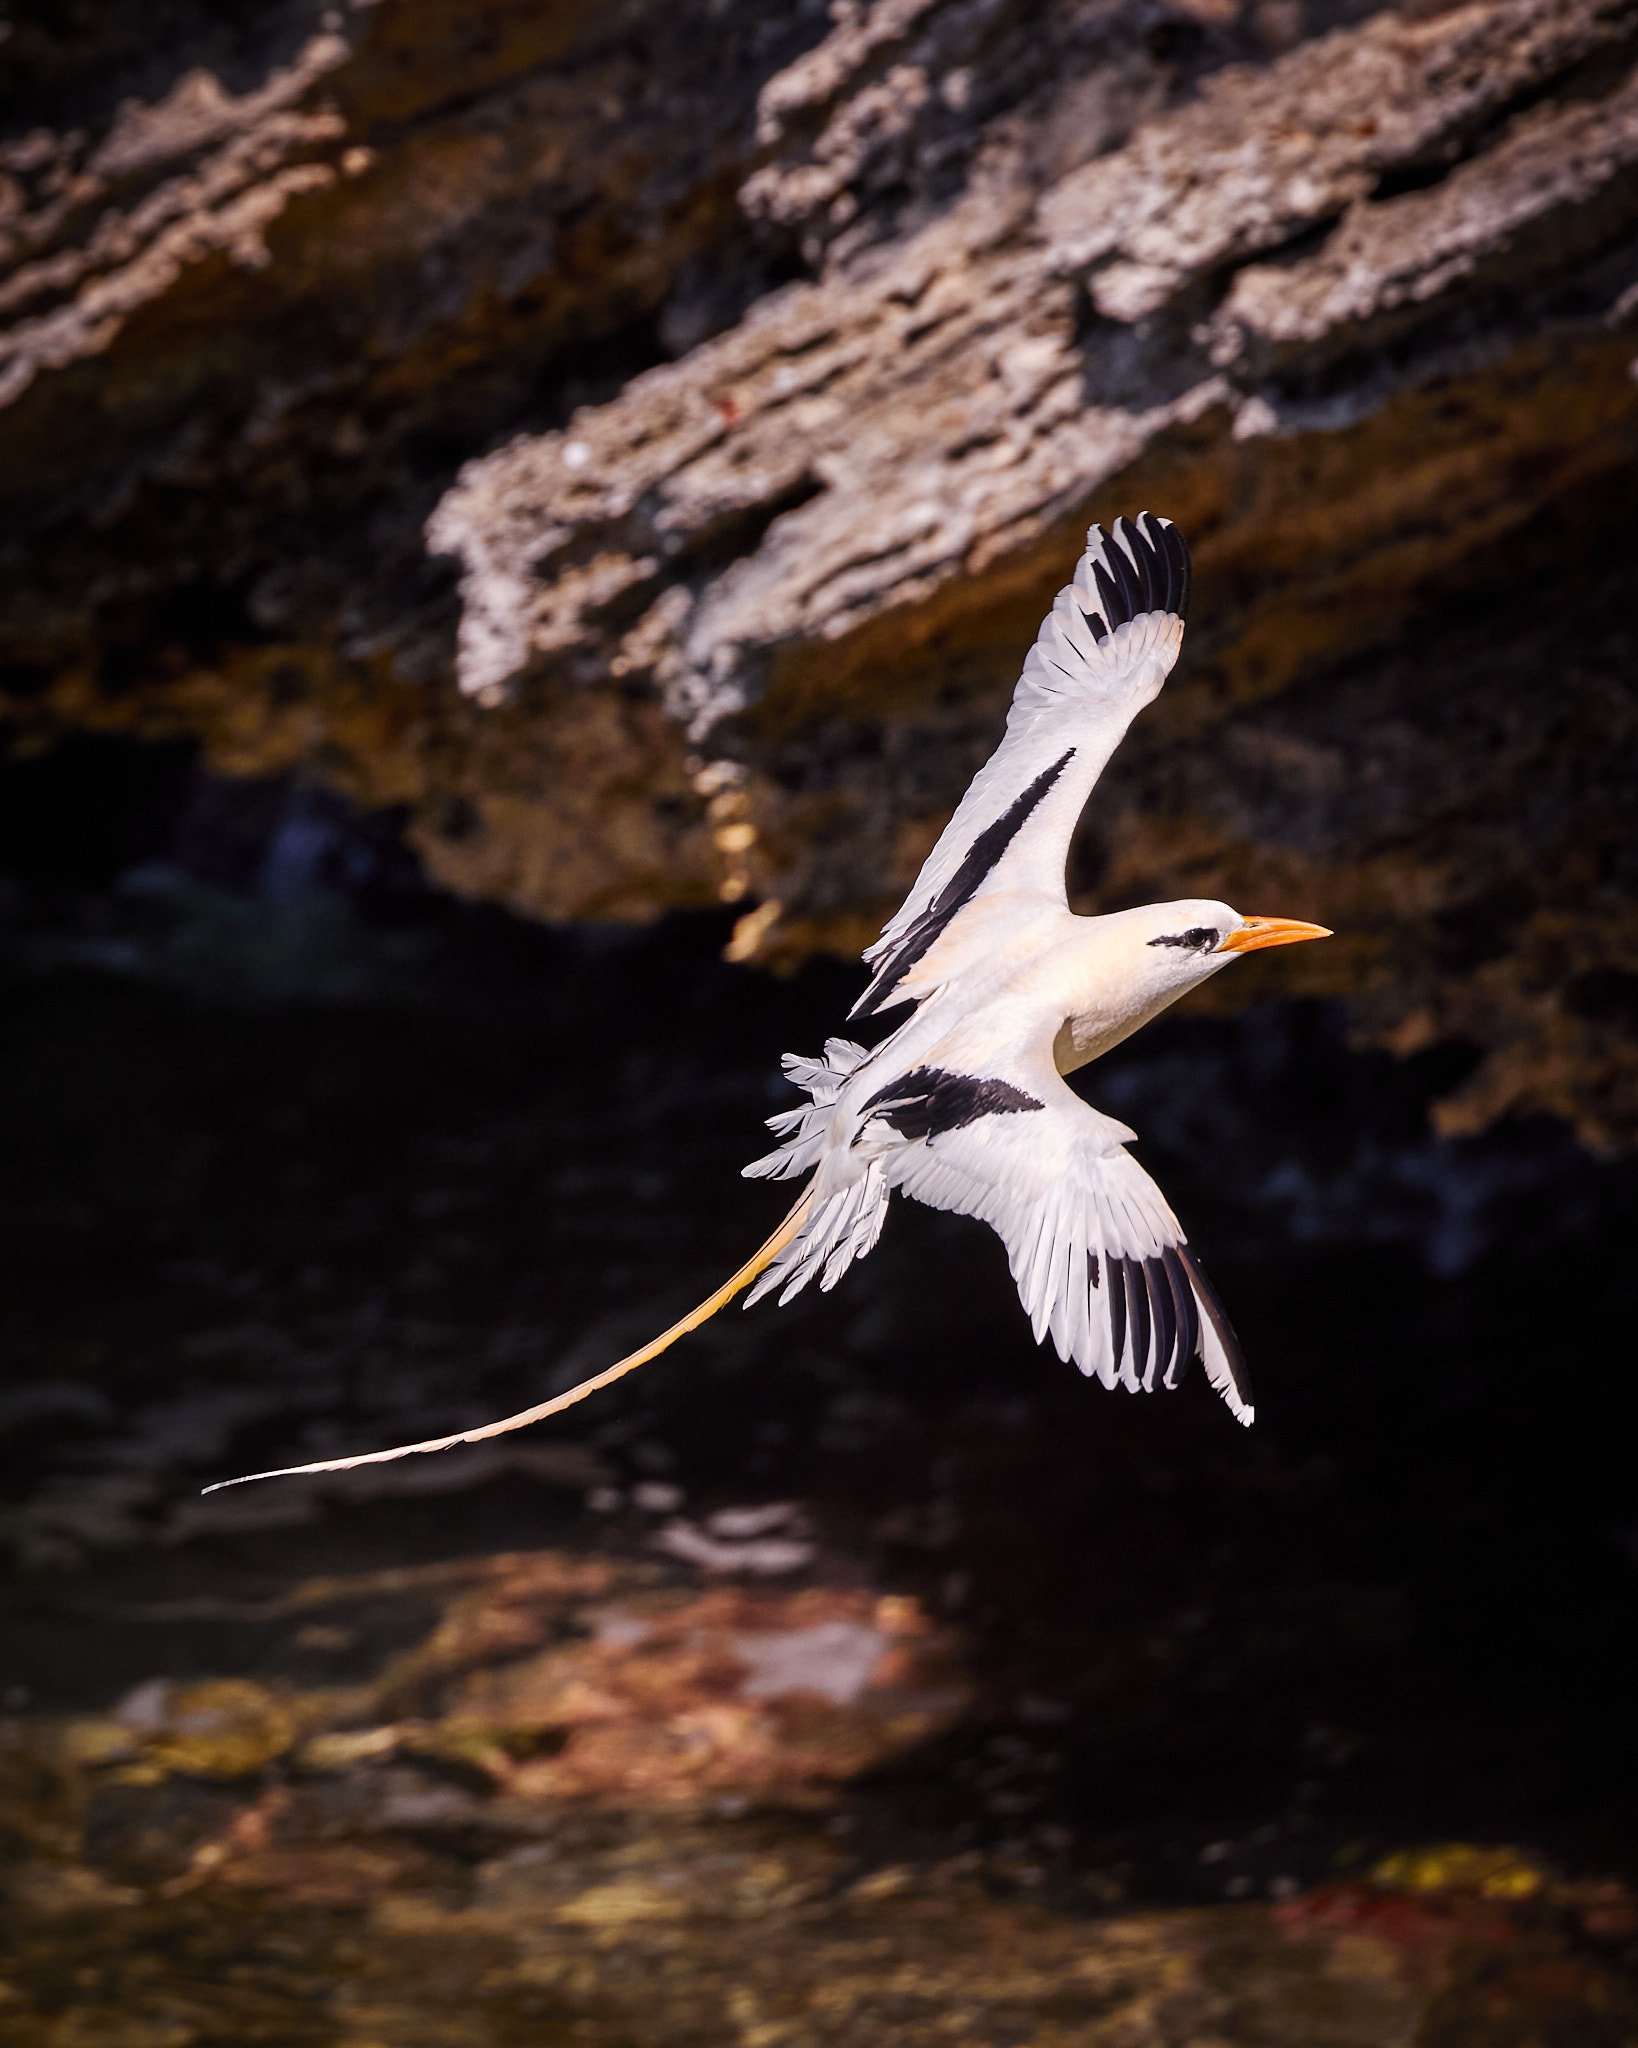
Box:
205 512 1331 1493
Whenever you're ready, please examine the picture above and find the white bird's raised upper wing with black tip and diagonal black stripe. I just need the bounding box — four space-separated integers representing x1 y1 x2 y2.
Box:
852 512 1190 1016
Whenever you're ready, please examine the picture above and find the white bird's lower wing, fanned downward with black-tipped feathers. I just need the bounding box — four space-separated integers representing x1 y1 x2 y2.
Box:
878 1069 1253 1423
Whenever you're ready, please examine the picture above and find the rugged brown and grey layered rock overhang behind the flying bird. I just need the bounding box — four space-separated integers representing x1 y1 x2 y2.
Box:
0 0 1638 1143
